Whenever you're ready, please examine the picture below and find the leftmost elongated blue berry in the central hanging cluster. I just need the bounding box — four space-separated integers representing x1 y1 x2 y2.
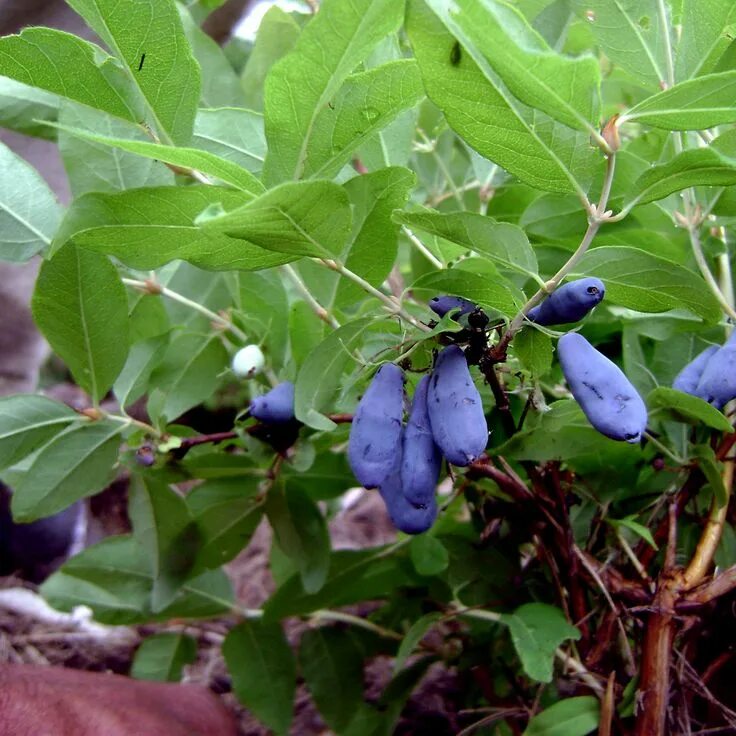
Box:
348 363 404 488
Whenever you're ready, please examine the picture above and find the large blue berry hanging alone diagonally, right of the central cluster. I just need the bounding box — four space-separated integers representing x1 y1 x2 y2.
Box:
557 332 647 443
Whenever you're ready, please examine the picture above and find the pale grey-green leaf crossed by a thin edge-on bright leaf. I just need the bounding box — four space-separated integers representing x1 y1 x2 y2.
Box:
56 104 174 197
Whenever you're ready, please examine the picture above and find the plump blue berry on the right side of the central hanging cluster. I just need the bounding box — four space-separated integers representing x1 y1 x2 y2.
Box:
427 345 488 466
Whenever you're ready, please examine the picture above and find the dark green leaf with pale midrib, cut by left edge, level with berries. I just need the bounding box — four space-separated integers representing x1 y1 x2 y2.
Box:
0 394 79 469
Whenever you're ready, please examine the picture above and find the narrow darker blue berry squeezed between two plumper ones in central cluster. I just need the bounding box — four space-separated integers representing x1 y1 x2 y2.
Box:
401 376 442 506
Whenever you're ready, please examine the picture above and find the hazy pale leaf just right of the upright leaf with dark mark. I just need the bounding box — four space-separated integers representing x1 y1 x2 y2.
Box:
176 3 243 107
